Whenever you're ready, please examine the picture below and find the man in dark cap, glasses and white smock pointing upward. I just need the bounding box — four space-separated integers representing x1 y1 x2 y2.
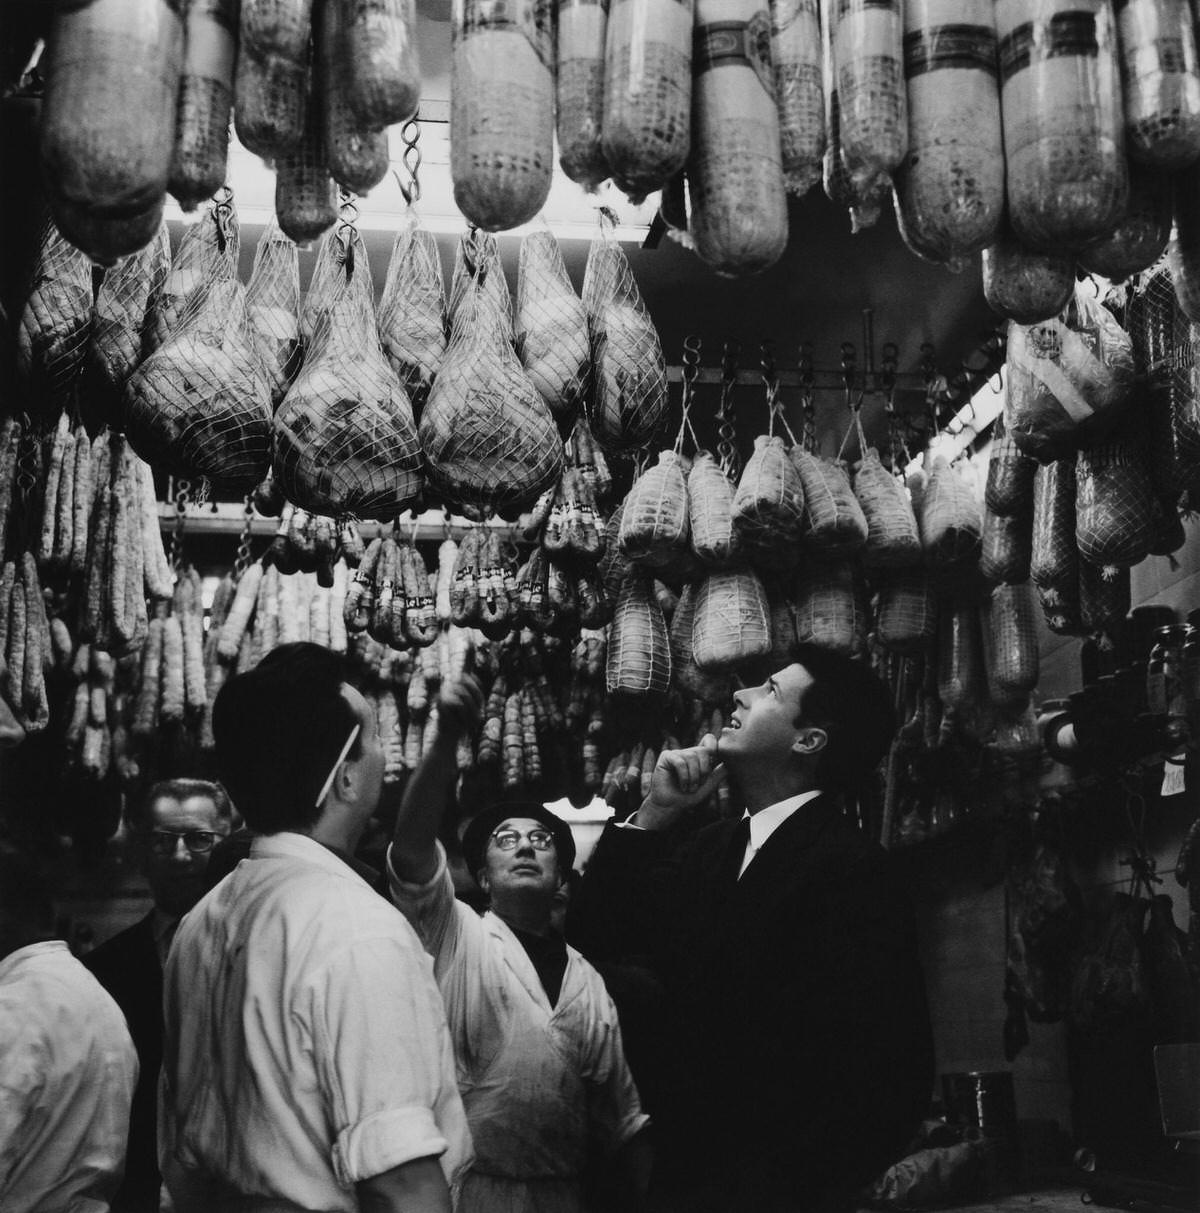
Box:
387 674 649 1213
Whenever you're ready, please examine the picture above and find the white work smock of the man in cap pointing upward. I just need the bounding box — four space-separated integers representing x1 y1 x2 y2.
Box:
388 843 649 1213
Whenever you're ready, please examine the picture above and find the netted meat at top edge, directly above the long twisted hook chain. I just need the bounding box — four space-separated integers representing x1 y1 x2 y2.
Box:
342 0 421 131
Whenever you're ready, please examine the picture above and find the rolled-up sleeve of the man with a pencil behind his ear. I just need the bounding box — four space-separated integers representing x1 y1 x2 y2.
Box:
312 938 454 1188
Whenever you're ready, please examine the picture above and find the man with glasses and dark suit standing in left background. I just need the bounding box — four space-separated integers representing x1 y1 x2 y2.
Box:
84 779 232 1213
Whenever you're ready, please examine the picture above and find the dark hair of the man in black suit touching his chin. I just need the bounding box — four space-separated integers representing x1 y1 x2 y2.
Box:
792 644 895 791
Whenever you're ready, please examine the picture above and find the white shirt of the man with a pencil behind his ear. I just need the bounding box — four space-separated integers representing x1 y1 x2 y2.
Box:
159 832 471 1213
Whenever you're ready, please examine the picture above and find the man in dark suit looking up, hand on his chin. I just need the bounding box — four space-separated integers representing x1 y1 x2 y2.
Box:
570 647 933 1213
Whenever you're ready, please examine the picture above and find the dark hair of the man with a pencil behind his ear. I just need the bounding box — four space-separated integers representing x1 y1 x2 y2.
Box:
212 642 359 833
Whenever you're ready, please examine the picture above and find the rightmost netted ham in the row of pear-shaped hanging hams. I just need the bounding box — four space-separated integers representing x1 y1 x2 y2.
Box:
584 229 676 452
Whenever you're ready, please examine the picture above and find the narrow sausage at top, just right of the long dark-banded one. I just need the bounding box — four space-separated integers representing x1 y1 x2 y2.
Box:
770 0 825 198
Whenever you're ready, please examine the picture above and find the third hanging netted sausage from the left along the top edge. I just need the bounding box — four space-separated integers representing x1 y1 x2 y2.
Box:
233 0 313 157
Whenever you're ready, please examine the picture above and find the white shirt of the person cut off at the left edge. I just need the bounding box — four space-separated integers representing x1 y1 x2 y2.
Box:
0 940 137 1213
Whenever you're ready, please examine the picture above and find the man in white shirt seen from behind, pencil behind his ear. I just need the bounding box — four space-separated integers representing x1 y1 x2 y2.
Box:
159 644 471 1213
